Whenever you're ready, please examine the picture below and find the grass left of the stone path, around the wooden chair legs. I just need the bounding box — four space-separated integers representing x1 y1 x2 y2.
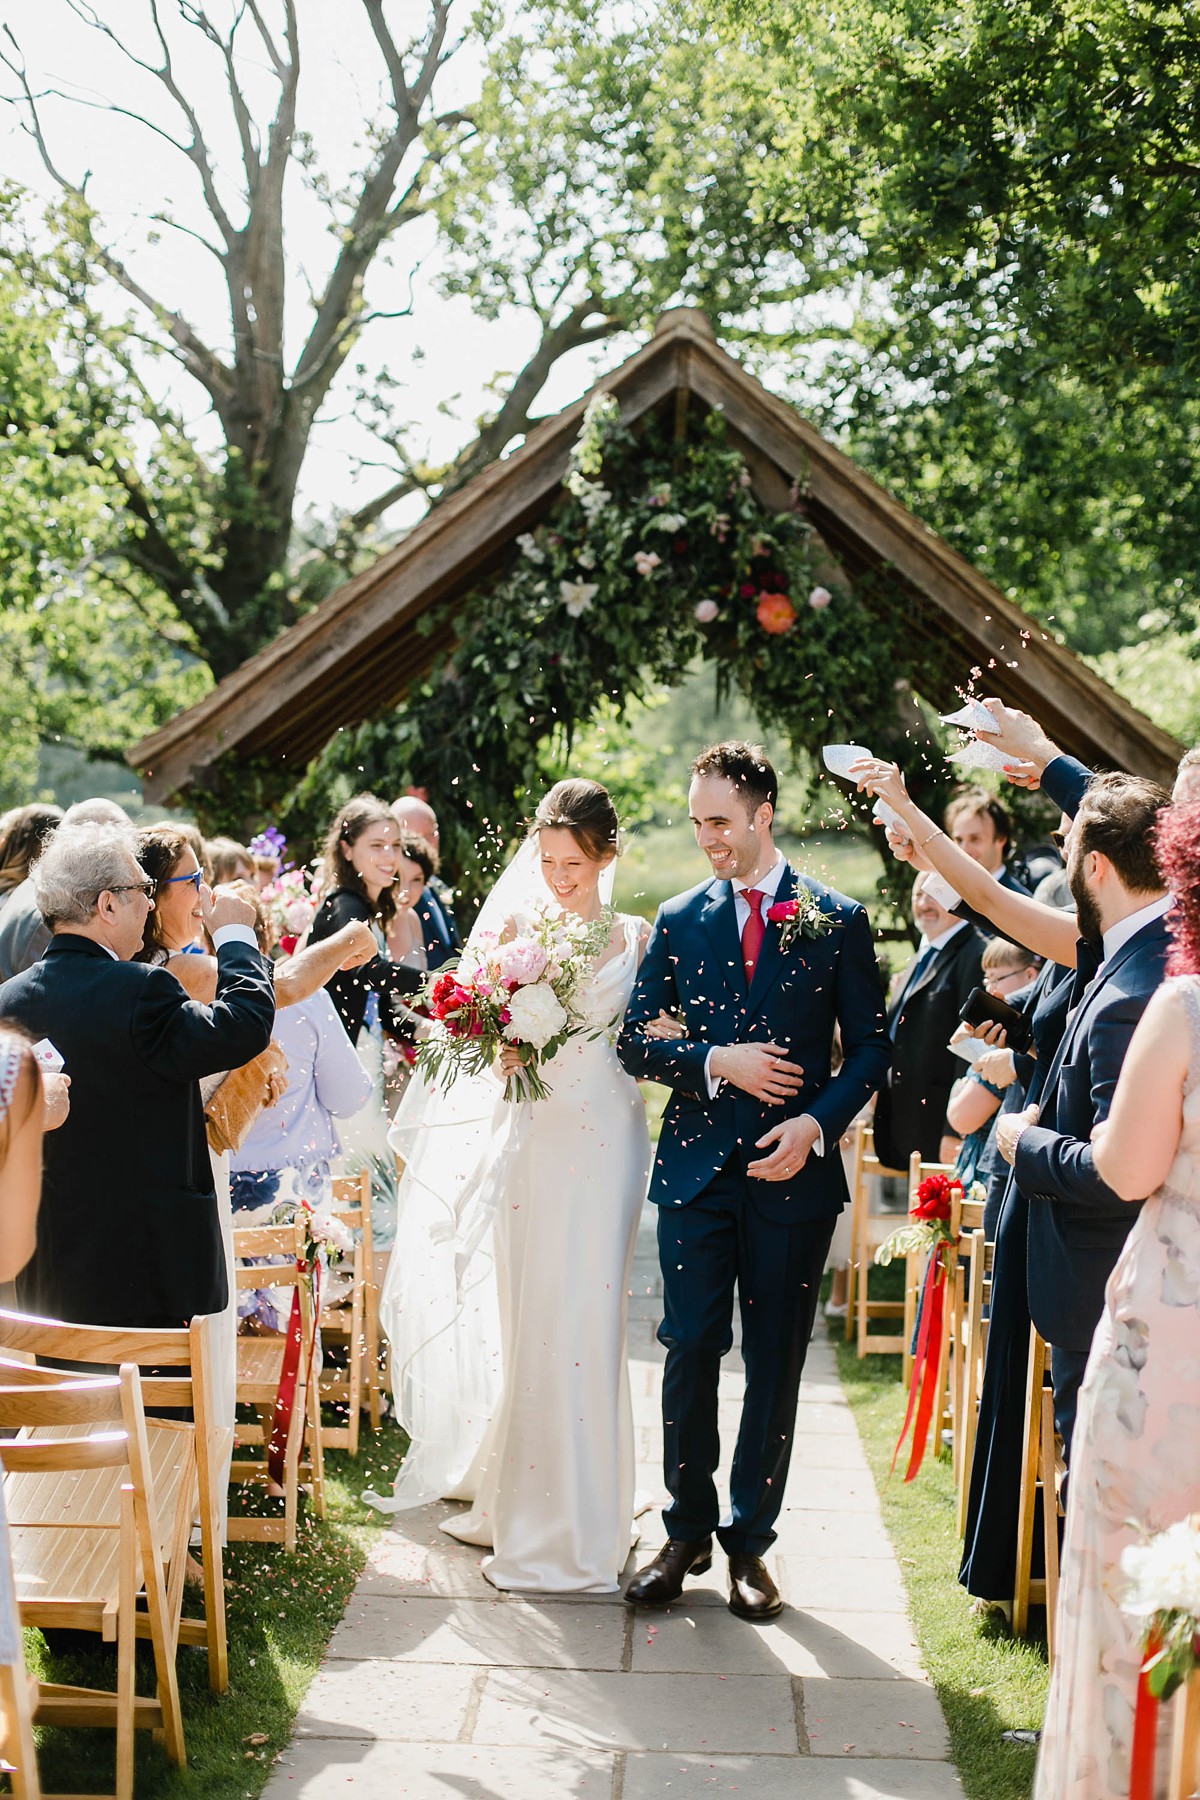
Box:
21 1420 408 1800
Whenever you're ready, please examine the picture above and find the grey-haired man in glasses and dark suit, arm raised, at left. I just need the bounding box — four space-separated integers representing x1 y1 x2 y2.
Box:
0 824 275 1330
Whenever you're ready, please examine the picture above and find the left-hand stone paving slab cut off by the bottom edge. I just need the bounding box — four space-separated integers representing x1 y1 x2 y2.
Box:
268 1741 613 1800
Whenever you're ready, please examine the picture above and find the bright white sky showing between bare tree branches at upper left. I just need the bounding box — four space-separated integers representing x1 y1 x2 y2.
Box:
0 0 644 526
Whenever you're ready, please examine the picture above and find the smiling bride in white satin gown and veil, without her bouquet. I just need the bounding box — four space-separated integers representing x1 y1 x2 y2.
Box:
367 781 649 1593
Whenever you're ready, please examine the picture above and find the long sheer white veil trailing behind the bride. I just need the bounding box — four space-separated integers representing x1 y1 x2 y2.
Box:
363 837 613 1512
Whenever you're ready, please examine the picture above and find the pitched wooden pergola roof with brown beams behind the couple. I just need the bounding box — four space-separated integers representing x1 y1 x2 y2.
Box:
130 308 1180 801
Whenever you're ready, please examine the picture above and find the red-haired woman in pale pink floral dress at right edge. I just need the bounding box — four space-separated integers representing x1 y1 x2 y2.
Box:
1036 803 1200 1800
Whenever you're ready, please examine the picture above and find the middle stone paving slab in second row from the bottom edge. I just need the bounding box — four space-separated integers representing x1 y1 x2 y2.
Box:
473 1669 799 1757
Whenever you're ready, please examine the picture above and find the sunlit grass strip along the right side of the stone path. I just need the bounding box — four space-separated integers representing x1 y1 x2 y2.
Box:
831 1321 1049 1800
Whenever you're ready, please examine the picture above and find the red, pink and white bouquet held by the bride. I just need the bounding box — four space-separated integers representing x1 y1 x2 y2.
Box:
417 907 612 1100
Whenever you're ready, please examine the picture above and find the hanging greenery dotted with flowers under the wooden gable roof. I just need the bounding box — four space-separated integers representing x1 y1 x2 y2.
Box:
260 394 949 889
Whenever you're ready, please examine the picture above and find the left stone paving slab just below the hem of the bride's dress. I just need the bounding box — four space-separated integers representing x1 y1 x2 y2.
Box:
327 1595 626 1669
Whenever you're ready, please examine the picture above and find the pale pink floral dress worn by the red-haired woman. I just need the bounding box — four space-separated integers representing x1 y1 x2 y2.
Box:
1034 976 1200 1800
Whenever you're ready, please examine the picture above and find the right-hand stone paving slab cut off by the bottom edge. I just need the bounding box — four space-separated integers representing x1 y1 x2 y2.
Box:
626 1753 963 1800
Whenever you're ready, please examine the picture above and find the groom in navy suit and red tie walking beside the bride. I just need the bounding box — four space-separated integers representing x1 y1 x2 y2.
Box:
617 743 891 1620
